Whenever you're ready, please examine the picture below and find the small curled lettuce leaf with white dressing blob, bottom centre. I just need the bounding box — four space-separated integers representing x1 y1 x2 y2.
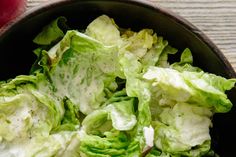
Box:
82 98 137 135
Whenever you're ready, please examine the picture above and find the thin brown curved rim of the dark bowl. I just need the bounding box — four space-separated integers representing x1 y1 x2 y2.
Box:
0 0 236 78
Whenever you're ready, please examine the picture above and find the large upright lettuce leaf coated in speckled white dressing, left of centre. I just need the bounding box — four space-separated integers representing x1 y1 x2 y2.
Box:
37 31 121 114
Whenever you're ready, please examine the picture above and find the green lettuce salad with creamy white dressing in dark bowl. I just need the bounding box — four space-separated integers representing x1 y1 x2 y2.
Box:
0 15 236 157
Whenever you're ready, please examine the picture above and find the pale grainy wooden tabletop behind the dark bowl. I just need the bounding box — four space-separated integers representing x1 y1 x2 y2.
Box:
27 0 236 70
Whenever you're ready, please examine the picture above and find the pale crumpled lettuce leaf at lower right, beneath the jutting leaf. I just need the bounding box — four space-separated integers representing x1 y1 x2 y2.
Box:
153 103 212 156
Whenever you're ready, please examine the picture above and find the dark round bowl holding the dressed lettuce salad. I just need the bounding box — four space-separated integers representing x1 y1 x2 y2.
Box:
0 0 236 157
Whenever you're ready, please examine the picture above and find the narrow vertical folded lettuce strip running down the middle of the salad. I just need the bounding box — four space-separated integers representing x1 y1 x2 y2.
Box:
120 51 151 154
